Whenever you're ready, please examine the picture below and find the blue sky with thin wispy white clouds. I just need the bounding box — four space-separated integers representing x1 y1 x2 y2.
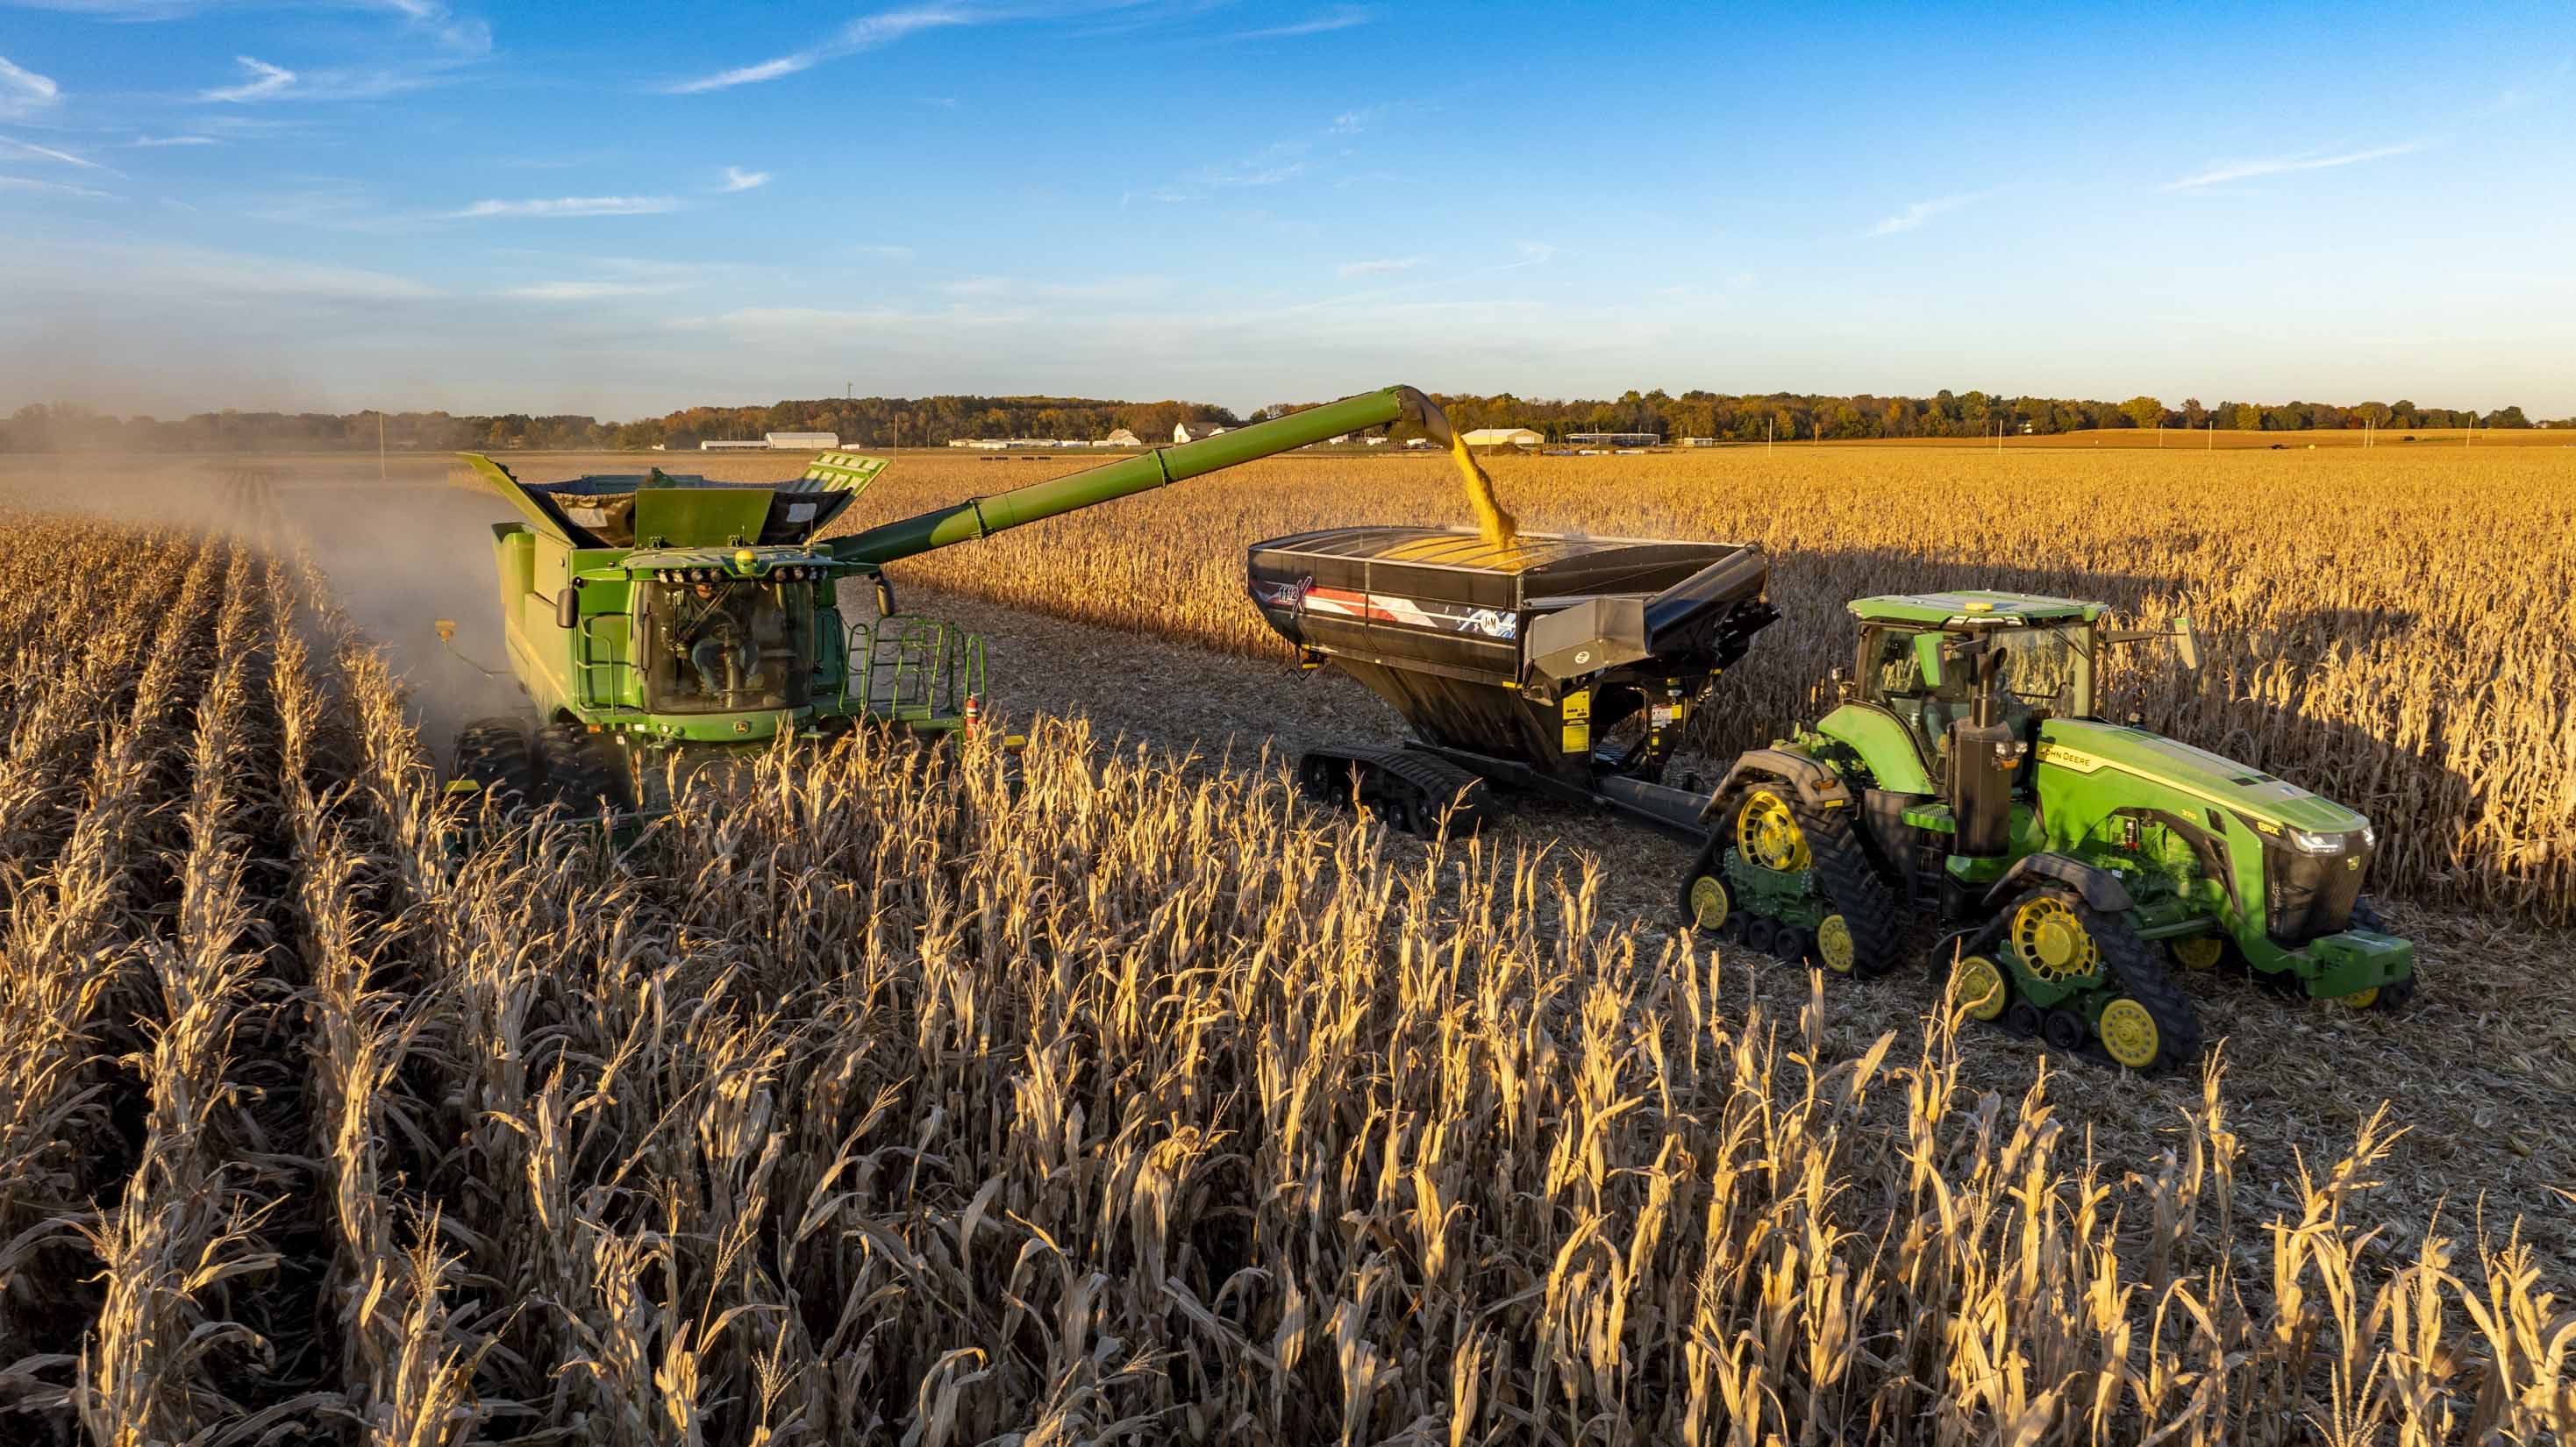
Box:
0 0 2576 417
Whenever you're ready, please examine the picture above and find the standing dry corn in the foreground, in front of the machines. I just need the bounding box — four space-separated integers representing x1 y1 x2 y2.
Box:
0 491 2576 1447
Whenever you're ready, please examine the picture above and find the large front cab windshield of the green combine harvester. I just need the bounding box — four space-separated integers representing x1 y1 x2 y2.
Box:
636 580 814 713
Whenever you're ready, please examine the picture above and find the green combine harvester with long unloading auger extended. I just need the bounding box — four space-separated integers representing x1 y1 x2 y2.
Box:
451 386 1451 811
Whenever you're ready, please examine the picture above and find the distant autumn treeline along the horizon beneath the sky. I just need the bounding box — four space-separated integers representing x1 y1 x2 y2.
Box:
0 388 2576 453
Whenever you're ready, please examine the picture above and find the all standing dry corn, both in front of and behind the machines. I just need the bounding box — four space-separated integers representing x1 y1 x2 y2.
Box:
0 448 2576 1447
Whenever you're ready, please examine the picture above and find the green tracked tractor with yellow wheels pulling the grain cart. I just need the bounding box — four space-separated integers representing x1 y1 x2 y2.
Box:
1682 592 2414 1071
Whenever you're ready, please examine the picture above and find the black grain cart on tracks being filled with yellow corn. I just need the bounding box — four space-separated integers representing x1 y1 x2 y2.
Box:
1247 528 1778 834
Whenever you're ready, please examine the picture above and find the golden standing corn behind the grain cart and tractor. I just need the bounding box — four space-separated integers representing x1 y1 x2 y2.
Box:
829 448 2576 924
